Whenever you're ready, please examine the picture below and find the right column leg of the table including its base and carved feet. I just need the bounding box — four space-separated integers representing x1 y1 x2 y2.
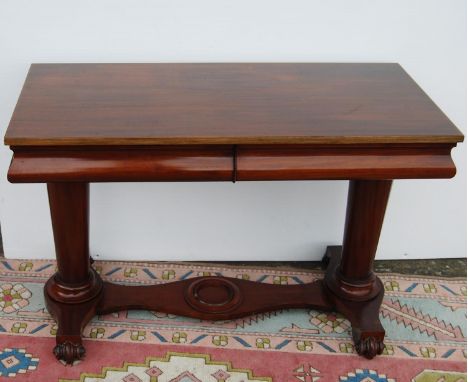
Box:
325 180 392 358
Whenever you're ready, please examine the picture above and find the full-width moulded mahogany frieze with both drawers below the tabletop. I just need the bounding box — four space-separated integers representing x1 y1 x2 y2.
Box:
8 144 456 183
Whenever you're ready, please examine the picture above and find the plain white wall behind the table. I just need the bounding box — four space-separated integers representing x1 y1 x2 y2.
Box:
0 0 467 260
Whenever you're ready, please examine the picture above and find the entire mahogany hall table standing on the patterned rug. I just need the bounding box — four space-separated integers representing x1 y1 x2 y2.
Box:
5 63 463 363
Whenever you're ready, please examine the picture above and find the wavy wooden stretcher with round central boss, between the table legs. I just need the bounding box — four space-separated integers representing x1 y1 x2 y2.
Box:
97 276 332 320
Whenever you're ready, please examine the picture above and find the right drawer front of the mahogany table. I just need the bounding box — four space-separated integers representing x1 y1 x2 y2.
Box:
236 144 456 181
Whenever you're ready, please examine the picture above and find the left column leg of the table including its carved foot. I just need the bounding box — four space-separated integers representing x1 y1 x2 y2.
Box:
44 183 102 364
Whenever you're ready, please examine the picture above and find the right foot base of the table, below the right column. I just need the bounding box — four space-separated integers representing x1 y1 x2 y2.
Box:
324 246 385 359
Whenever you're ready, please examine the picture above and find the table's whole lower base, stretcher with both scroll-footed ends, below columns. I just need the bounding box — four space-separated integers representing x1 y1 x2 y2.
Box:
45 246 385 364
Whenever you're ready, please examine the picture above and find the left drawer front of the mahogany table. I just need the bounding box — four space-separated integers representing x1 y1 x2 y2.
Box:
8 146 234 183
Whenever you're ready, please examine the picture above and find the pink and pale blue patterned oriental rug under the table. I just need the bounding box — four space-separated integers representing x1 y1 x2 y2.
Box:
0 260 466 382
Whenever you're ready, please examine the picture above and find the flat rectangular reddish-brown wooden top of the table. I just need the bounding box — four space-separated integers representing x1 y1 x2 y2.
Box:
5 63 463 147
